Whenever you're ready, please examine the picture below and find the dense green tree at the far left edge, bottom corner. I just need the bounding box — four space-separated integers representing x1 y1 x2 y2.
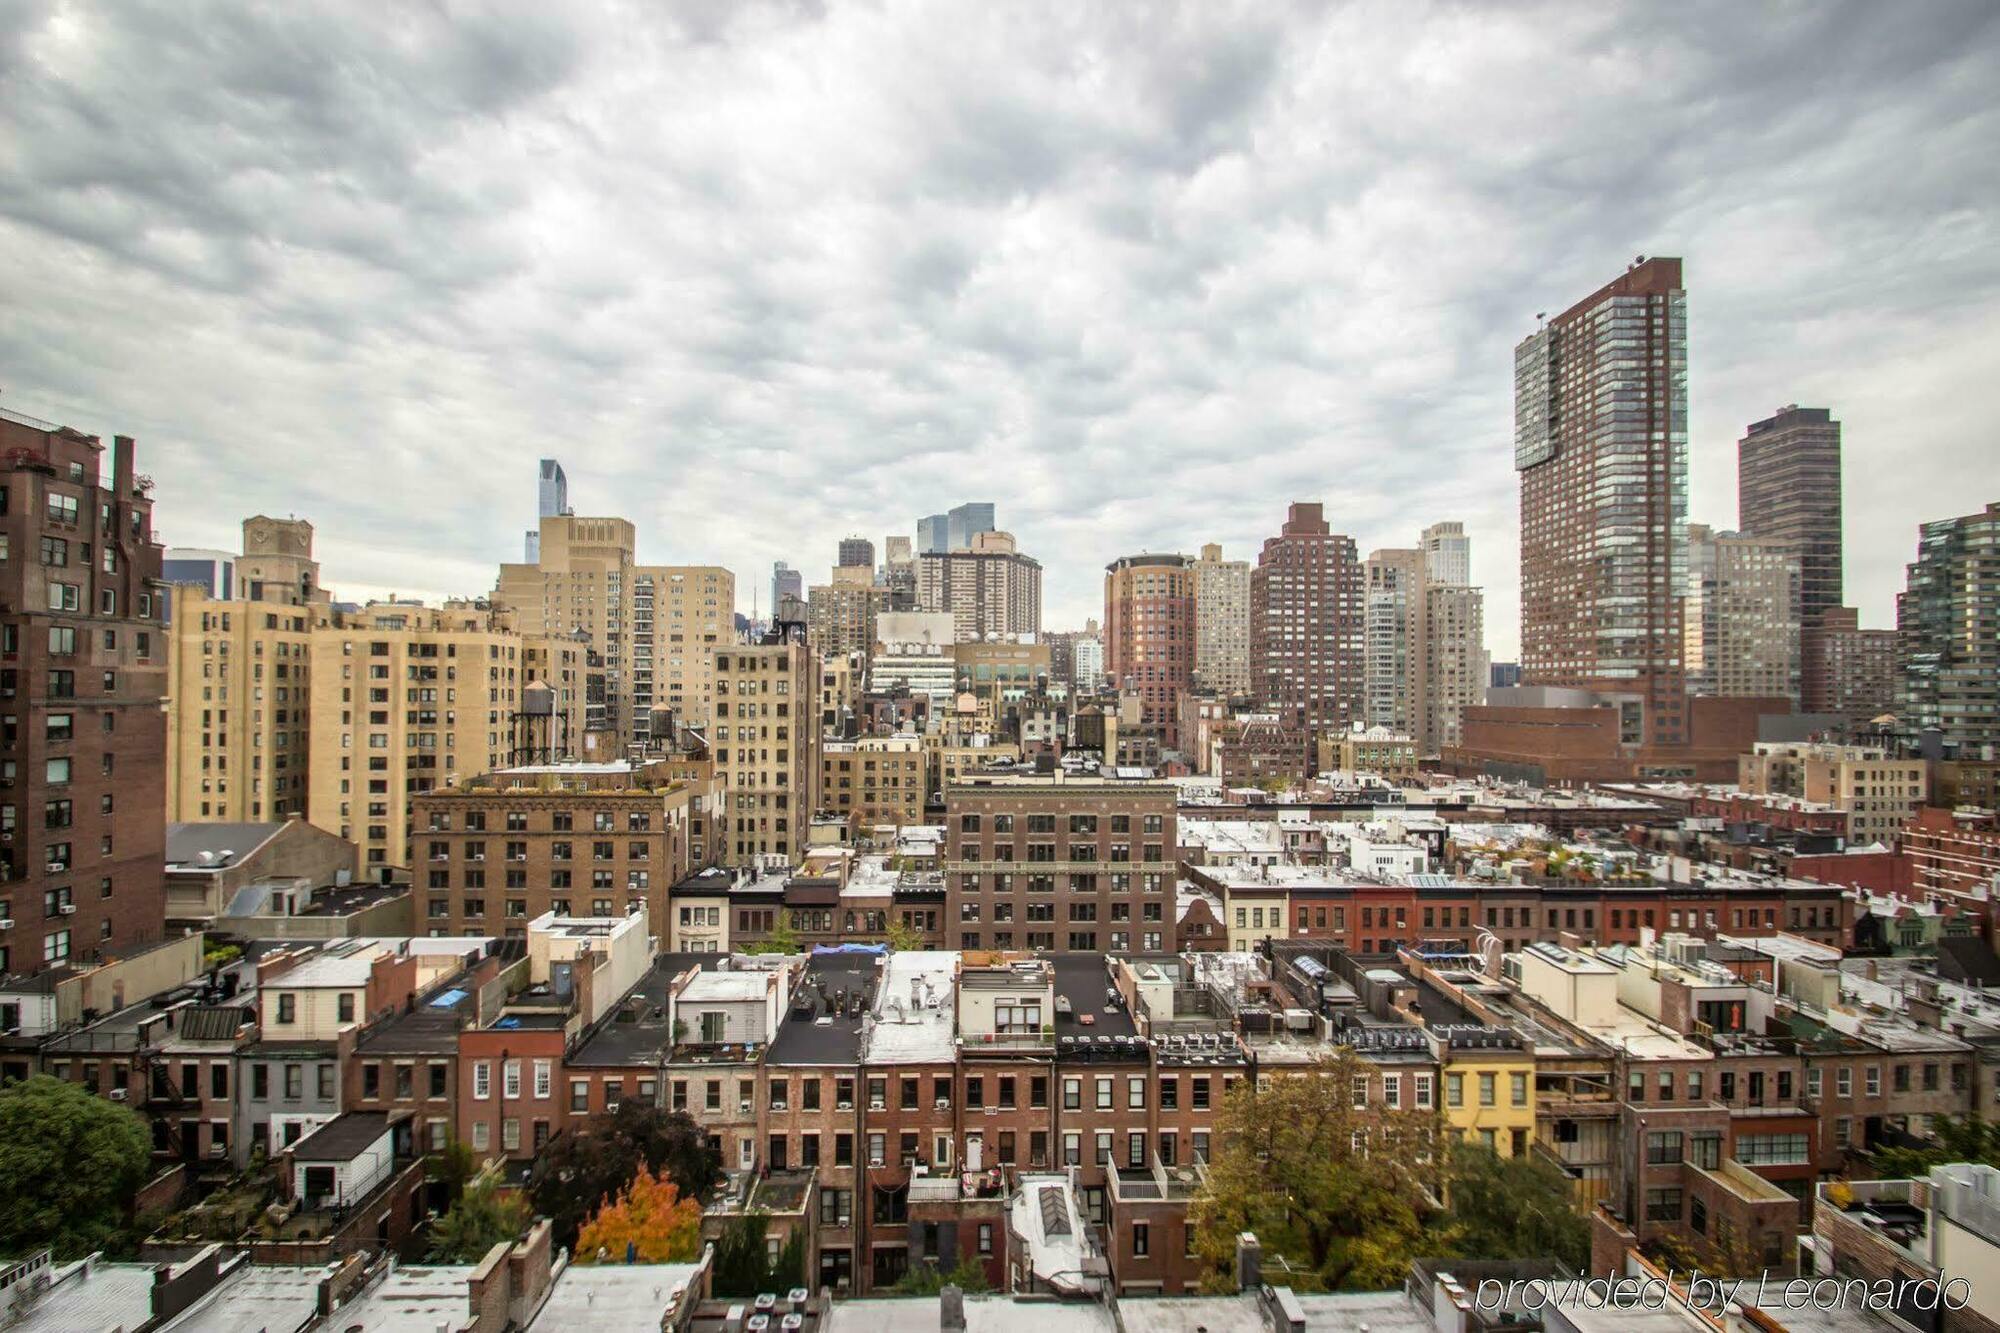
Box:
0 1075 152 1259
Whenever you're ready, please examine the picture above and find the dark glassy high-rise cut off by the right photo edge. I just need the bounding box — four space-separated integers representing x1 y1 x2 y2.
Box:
1896 500 2000 759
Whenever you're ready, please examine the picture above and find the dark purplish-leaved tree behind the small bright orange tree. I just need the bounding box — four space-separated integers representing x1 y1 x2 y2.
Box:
528 1101 724 1248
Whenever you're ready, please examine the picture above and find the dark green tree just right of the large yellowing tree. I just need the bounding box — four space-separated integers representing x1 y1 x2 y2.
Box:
1444 1143 1590 1269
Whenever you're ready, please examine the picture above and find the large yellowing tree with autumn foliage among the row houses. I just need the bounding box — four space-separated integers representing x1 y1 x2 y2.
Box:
1190 1047 1438 1291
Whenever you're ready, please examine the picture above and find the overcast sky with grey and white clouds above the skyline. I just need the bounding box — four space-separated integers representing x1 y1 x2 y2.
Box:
0 0 2000 658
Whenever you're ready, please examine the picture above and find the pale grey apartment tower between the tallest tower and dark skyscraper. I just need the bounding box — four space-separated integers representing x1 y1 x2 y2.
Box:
1682 522 1802 705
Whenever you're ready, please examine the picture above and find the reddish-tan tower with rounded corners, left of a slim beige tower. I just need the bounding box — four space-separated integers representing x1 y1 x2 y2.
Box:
1104 554 1194 745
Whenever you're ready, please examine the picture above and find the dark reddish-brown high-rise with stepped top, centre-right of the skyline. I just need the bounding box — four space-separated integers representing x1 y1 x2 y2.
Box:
1250 504 1366 731
